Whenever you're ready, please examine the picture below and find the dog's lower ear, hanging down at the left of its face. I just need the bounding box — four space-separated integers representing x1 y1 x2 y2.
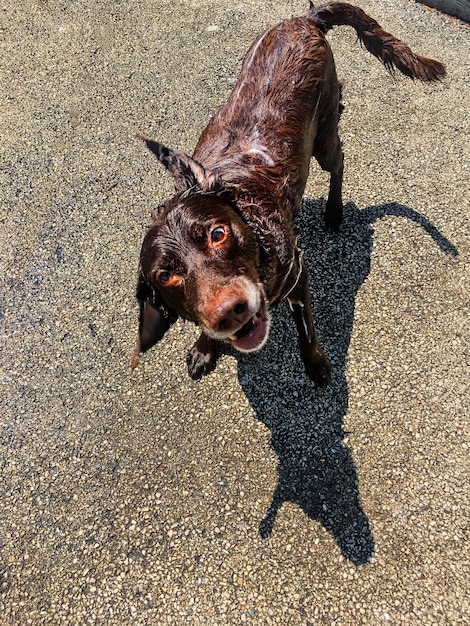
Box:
131 271 178 370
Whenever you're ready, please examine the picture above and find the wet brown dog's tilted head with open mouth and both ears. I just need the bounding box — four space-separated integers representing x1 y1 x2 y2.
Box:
133 140 269 367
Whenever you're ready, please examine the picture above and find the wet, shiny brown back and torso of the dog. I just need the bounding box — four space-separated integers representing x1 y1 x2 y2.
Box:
193 17 339 217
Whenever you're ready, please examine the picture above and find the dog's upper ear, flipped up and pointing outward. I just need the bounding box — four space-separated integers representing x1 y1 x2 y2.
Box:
137 135 222 192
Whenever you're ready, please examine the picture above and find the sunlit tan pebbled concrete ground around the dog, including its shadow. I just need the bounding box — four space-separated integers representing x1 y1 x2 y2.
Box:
0 0 470 626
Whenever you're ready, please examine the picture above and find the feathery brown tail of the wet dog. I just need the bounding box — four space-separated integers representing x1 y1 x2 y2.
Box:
308 2 446 82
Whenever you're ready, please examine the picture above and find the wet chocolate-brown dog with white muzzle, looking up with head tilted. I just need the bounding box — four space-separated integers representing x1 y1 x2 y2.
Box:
132 2 446 387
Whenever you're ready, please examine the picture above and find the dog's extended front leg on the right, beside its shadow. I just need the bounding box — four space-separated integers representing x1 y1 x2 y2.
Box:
288 259 331 387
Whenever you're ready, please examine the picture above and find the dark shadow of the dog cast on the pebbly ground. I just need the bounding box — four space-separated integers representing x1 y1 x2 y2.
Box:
233 200 457 565
